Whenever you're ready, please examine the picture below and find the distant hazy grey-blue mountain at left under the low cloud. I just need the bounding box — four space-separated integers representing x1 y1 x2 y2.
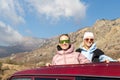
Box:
0 37 48 58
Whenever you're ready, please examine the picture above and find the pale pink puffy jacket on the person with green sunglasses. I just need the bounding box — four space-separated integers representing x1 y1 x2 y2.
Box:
52 45 90 65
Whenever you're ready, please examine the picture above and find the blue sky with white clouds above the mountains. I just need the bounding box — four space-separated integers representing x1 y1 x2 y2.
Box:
0 0 120 45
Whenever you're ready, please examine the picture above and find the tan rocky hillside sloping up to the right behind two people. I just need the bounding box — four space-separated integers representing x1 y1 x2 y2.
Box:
1 18 120 80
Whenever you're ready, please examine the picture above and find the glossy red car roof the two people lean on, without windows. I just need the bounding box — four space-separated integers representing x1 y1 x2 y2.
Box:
13 62 120 77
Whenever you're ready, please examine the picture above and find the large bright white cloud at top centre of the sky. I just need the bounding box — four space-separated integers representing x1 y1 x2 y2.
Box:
25 0 86 20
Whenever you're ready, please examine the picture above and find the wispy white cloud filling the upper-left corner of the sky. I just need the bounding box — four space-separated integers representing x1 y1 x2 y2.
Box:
0 0 25 25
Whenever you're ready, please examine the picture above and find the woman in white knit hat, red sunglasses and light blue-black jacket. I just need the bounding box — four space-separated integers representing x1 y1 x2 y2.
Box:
76 32 117 62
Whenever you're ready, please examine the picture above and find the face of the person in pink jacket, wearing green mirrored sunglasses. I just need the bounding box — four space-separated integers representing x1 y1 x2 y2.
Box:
59 35 70 50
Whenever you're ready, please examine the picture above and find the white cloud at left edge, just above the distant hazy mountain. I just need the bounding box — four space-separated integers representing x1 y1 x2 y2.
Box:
0 21 23 45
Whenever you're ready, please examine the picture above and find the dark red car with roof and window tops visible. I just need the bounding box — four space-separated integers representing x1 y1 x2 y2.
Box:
8 62 120 80
